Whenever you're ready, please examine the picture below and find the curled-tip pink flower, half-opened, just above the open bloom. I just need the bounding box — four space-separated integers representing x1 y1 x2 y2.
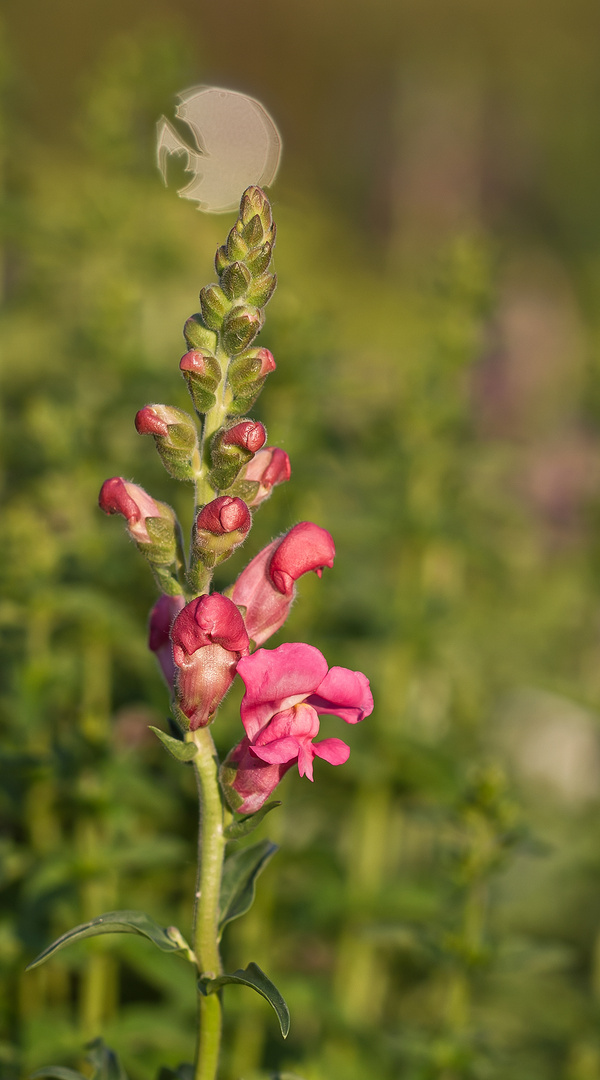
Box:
231 522 336 645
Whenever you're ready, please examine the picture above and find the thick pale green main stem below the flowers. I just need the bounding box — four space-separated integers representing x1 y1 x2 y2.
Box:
187 728 226 1080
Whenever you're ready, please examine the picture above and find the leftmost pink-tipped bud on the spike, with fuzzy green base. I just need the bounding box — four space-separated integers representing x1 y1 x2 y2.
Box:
98 476 181 595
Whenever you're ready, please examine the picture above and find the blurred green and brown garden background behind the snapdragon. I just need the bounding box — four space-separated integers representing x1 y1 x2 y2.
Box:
5 0 600 1080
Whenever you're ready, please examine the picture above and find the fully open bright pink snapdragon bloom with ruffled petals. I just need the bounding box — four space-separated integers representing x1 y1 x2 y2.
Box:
220 644 373 813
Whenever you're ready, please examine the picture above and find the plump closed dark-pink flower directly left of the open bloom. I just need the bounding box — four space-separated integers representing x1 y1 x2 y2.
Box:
171 593 249 731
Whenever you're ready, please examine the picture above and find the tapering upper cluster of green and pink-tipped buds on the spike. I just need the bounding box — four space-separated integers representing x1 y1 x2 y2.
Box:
100 187 290 599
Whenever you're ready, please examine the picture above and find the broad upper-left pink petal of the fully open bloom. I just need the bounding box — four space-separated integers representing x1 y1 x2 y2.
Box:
237 644 327 740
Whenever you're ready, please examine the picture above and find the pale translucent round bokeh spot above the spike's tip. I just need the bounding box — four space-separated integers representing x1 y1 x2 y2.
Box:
156 86 282 214
